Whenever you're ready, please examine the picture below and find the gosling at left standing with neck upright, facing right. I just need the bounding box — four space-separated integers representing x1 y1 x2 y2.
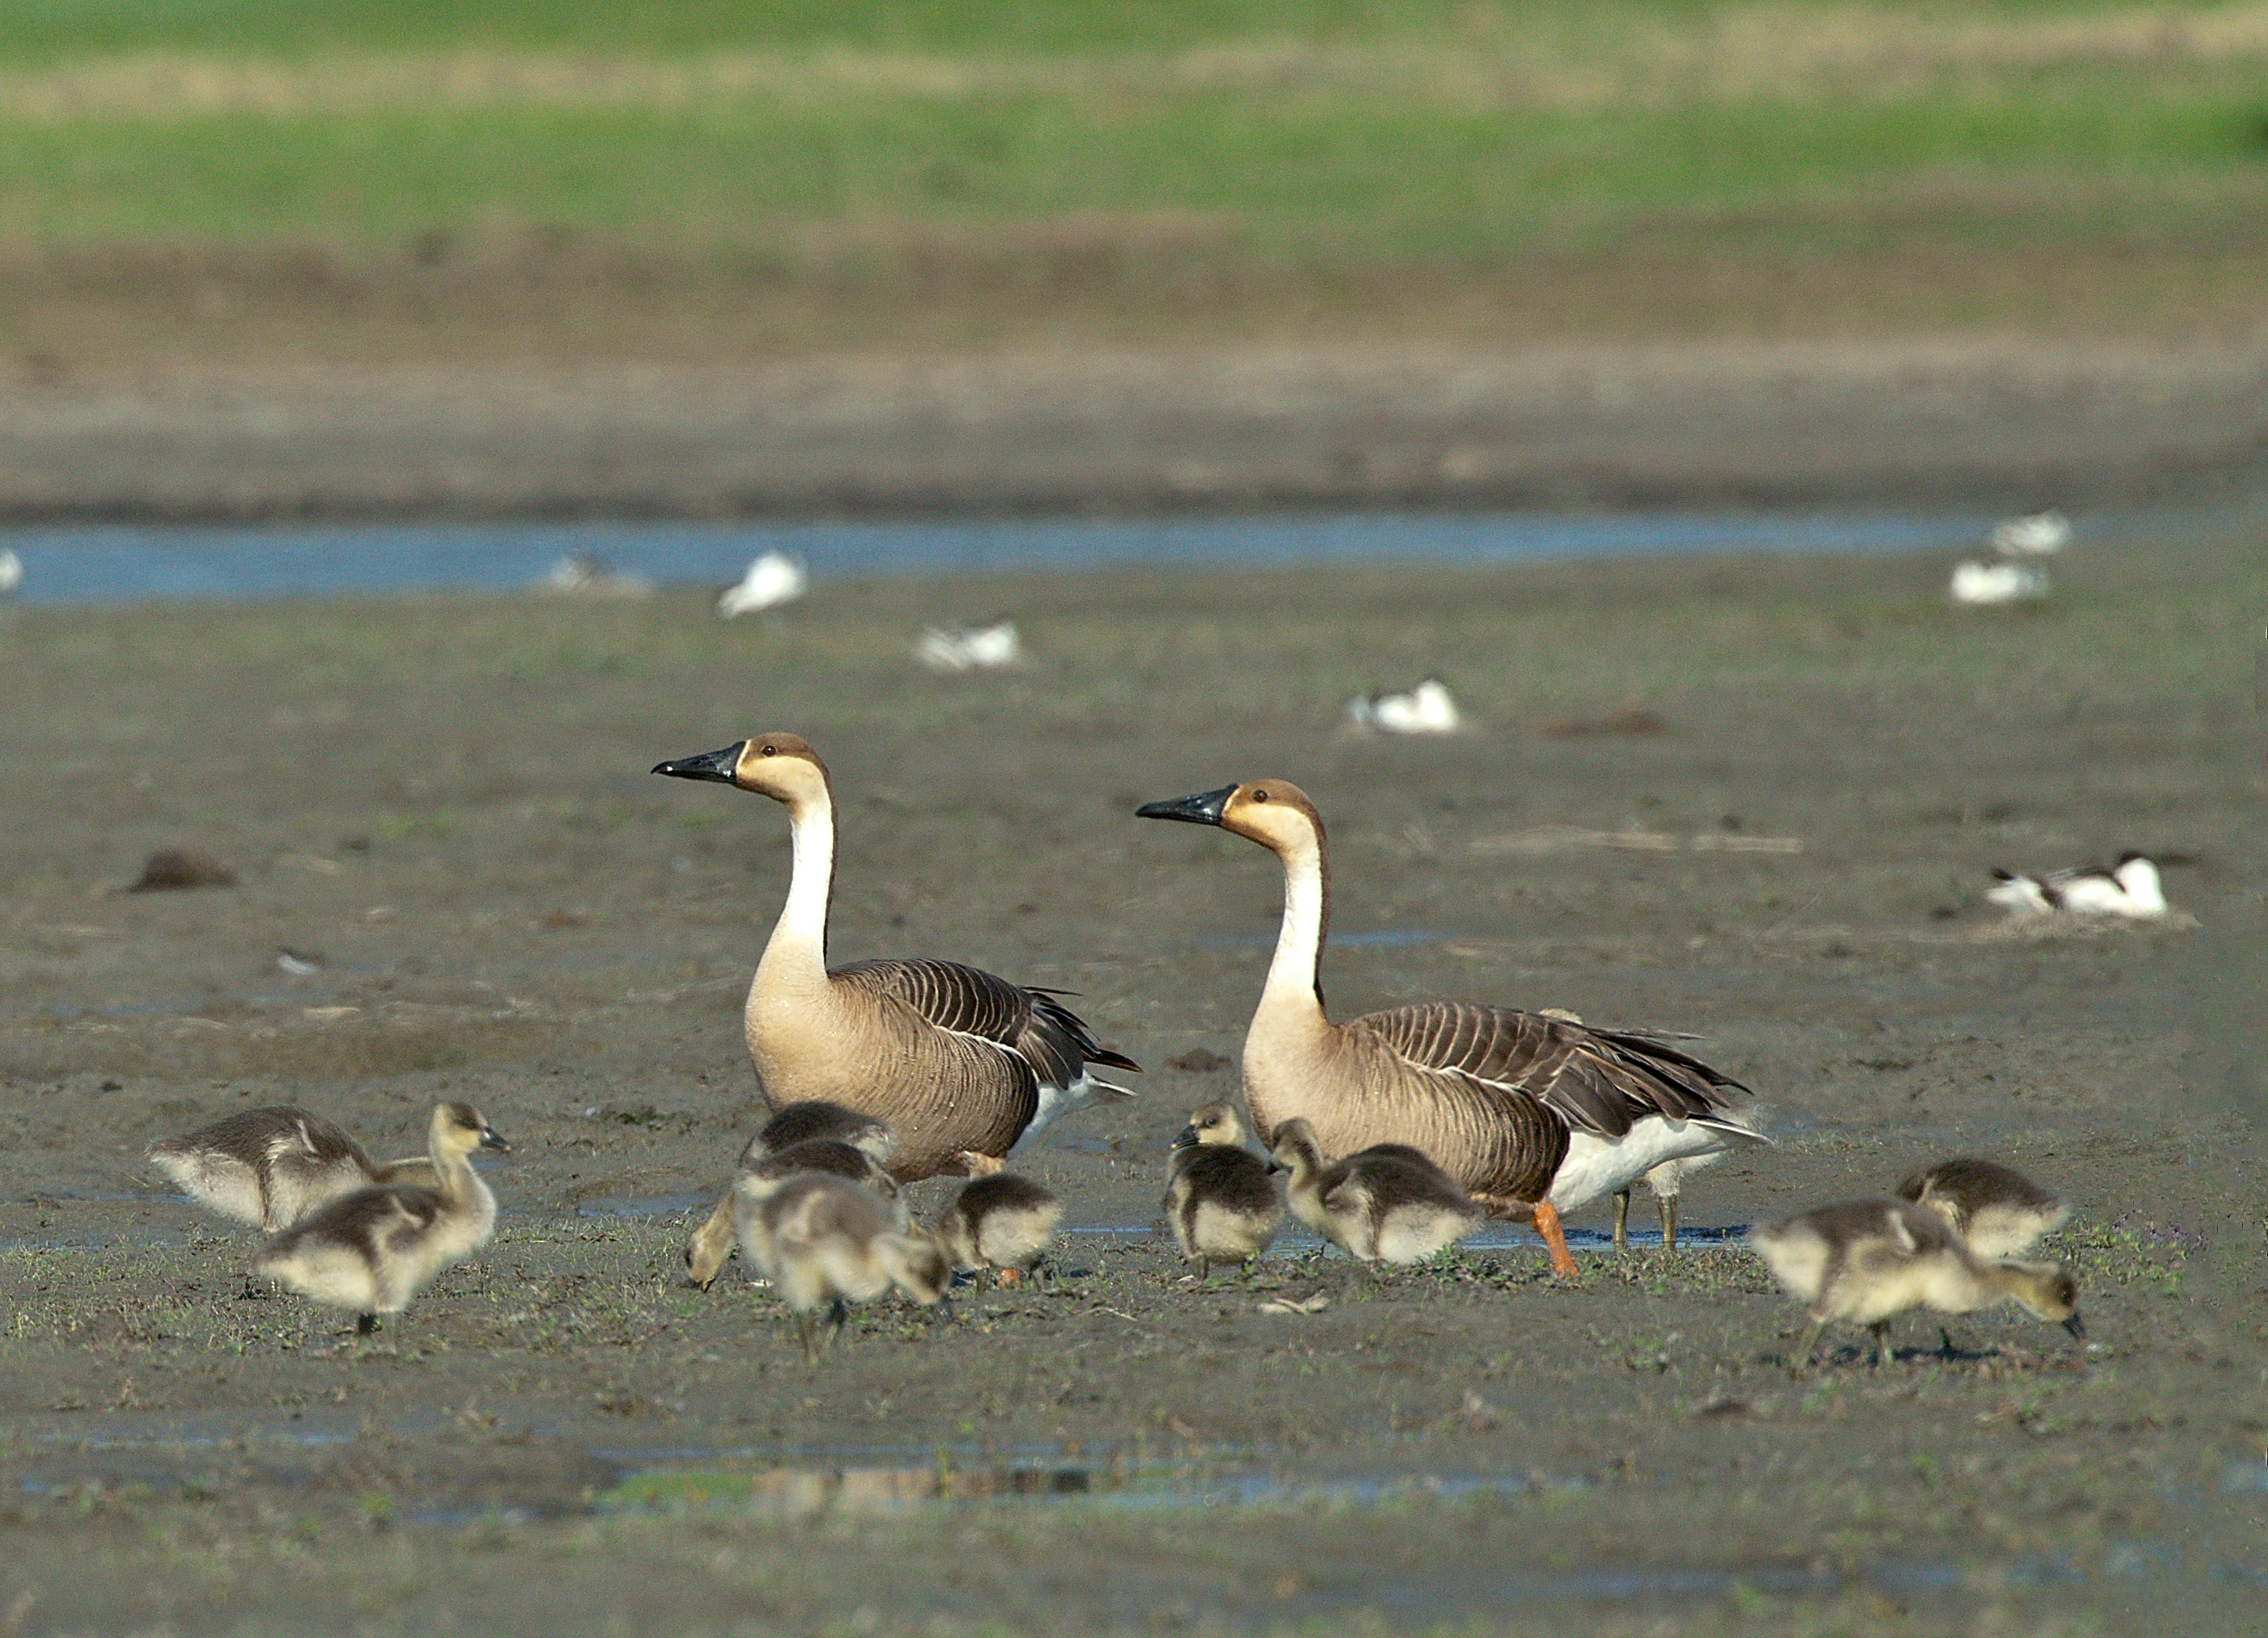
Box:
252 1103 512 1337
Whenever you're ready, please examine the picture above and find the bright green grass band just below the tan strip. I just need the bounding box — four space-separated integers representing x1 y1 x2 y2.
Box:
0 73 2268 251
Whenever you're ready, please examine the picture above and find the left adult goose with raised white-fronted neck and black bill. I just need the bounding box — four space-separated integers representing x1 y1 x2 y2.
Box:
653 733 1141 1182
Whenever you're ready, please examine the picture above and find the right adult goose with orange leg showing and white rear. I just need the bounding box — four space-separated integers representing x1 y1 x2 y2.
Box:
1139 778 1769 1275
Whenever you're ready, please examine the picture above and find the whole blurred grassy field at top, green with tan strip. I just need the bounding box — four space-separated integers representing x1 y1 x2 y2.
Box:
0 0 2268 288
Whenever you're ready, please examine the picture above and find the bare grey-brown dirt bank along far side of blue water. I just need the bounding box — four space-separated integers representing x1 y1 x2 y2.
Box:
0 338 2268 522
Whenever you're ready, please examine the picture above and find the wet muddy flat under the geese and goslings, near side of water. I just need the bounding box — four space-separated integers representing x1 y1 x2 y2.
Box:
0 537 2268 1633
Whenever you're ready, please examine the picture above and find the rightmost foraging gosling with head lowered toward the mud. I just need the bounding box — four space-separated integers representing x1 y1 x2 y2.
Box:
1749 1200 2087 1368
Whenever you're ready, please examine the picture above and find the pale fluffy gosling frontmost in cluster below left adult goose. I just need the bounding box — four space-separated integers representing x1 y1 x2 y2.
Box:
732 1170 953 1366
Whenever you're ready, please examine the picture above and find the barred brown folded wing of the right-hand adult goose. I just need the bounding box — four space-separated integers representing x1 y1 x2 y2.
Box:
1345 1003 1749 1137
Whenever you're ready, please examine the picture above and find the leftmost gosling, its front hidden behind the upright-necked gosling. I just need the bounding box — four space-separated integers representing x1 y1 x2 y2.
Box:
143 1103 436 1234
